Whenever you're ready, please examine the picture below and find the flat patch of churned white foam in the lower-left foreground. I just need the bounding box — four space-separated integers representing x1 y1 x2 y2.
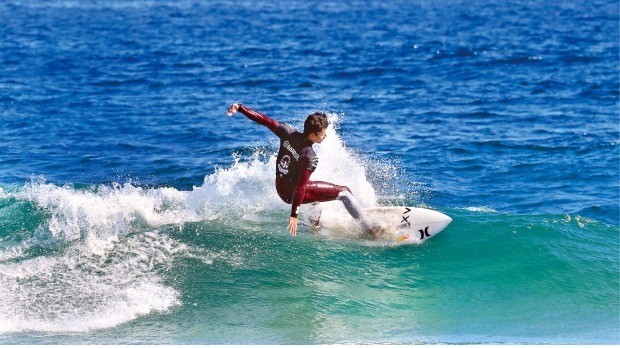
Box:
0 234 185 333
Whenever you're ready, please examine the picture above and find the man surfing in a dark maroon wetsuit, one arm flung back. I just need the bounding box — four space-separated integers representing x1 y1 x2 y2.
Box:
228 104 381 237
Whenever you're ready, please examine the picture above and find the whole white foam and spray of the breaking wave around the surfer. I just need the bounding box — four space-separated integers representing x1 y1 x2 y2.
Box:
0 115 392 334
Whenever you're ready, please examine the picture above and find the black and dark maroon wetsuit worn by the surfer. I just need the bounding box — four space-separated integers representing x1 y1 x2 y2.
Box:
239 104 351 217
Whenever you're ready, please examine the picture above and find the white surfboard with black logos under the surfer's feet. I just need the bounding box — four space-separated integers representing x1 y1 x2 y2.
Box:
300 207 452 245
